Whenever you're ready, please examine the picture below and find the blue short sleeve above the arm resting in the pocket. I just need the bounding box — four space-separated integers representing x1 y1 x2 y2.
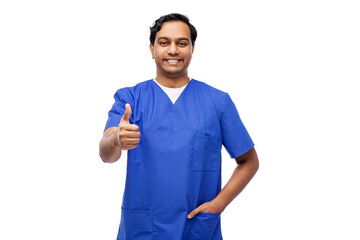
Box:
220 94 254 158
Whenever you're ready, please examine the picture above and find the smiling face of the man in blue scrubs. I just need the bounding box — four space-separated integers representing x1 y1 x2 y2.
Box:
150 21 194 78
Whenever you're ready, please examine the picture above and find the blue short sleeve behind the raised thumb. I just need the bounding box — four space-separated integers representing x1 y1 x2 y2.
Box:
105 88 134 130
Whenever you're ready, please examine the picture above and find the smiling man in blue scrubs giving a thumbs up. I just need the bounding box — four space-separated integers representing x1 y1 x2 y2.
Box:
100 14 259 240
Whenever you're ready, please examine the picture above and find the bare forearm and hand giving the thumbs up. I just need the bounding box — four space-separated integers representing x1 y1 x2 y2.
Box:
99 104 140 163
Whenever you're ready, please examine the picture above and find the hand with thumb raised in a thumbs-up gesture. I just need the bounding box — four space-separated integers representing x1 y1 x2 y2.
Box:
118 103 140 150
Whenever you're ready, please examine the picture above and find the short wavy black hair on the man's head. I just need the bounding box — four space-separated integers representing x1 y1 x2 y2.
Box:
149 13 197 45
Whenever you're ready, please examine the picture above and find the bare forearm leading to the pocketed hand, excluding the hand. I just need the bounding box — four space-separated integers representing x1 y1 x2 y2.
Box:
214 149 259 211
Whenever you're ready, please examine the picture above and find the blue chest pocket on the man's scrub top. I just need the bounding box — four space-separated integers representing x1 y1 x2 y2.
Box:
191 131 221 171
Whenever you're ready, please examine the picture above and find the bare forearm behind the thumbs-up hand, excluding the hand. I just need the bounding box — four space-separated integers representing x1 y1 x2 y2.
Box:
99 132 121 163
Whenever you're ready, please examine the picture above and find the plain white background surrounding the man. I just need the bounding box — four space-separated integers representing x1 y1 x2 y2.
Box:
0 0 360 240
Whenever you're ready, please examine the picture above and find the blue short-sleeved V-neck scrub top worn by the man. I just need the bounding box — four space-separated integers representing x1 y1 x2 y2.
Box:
105 79 254 240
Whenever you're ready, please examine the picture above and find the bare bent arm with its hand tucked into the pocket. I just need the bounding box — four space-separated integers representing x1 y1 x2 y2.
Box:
188 148 259 218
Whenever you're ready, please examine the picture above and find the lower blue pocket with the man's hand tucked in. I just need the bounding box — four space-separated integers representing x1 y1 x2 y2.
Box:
188 212 220 240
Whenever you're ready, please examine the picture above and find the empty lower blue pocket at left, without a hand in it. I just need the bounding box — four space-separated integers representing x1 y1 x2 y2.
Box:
117 208 152 240
